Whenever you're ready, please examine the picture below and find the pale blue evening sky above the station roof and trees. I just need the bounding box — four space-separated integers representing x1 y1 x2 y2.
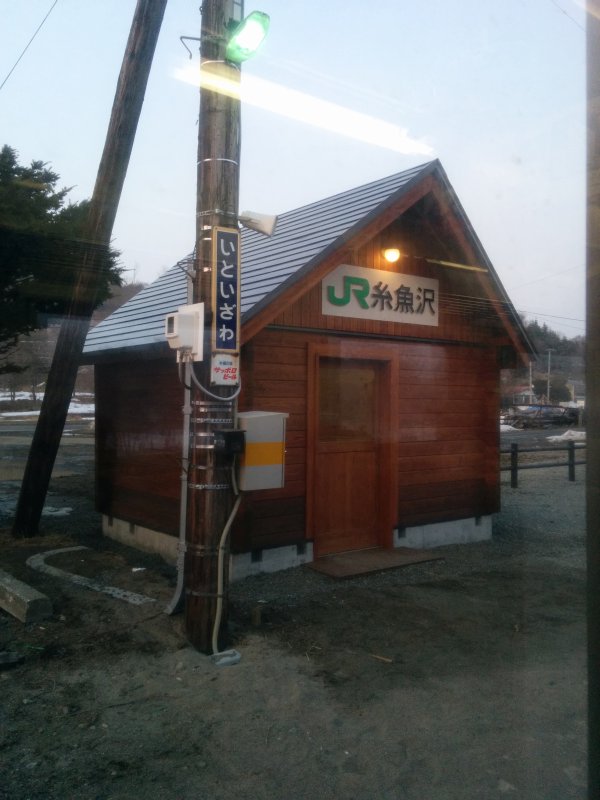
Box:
0 0 586 337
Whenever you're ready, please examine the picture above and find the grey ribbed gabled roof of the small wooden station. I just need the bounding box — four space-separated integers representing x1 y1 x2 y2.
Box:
84 160 527 356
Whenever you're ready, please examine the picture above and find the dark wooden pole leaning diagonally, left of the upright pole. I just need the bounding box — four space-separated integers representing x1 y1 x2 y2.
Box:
13 0 167 536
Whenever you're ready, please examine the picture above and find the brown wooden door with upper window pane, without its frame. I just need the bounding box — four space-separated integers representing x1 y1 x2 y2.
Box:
312 356 386 557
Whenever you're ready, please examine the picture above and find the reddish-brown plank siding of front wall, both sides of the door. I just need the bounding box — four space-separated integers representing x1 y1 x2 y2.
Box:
232 329 499 552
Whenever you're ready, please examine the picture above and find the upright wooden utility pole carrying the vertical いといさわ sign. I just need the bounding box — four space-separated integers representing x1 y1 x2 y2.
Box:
184 0 241 653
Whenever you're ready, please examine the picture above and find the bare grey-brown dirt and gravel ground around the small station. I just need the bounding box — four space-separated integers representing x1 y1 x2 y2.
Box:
0 432 586 800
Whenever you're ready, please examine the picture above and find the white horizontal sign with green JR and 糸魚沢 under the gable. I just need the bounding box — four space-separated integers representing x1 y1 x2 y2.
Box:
322 264 439 326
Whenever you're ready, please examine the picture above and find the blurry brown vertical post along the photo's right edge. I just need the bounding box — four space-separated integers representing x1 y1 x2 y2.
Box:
585 0 600 800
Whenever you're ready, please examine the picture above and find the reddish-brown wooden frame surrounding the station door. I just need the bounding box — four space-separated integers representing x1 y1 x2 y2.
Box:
306 339 399 558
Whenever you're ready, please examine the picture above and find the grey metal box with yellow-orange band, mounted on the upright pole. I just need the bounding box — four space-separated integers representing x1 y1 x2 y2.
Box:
238 411 288 492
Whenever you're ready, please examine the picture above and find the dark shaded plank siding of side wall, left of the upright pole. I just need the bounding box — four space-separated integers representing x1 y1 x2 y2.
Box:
96 360 183 535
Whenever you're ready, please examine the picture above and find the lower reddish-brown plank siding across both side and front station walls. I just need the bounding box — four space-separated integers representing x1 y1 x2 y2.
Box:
96 329 499 552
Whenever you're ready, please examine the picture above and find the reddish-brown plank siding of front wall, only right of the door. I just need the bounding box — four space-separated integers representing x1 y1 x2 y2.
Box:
398 345 499 527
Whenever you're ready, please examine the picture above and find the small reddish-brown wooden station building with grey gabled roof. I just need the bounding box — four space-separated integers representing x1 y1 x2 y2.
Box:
85 160 531 579
